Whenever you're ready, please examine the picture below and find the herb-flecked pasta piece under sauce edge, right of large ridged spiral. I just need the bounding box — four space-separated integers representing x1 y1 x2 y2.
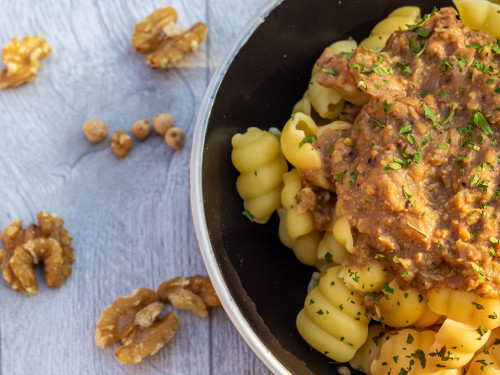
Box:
378 280 440 328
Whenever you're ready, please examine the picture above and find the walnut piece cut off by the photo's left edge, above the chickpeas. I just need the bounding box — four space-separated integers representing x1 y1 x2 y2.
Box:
0 35 51 89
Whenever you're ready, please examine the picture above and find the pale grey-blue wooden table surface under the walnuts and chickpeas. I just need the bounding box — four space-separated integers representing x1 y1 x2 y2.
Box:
0 0 269 375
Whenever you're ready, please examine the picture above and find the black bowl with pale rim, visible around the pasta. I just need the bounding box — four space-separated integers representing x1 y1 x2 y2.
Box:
191 0 453 375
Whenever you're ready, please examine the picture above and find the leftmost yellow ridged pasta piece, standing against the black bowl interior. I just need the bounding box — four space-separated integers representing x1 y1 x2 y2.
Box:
231 127 288 223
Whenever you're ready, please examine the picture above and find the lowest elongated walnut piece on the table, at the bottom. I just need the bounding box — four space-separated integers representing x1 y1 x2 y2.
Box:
115 311 179 364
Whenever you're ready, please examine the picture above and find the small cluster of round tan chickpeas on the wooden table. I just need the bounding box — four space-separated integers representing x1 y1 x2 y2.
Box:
83 113 186 158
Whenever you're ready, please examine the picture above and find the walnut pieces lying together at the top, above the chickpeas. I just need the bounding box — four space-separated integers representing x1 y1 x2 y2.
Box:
132 6 208 69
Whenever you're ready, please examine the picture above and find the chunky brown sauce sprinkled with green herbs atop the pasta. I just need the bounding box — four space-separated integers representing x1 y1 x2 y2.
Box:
317 8 500 297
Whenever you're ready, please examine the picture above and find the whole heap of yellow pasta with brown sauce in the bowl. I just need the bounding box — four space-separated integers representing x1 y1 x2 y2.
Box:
192 1 500 375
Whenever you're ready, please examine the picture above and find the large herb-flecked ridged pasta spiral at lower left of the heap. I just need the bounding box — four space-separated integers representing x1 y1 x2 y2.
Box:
296 266 370 362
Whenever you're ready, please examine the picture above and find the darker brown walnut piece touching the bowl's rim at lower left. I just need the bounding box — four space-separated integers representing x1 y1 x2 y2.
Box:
157 275 220 317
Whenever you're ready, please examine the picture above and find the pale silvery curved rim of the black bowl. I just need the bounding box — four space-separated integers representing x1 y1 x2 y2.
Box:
190 0 291 375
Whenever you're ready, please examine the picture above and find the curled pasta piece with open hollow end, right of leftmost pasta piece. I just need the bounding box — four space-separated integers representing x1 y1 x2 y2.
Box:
281 112 321 171
